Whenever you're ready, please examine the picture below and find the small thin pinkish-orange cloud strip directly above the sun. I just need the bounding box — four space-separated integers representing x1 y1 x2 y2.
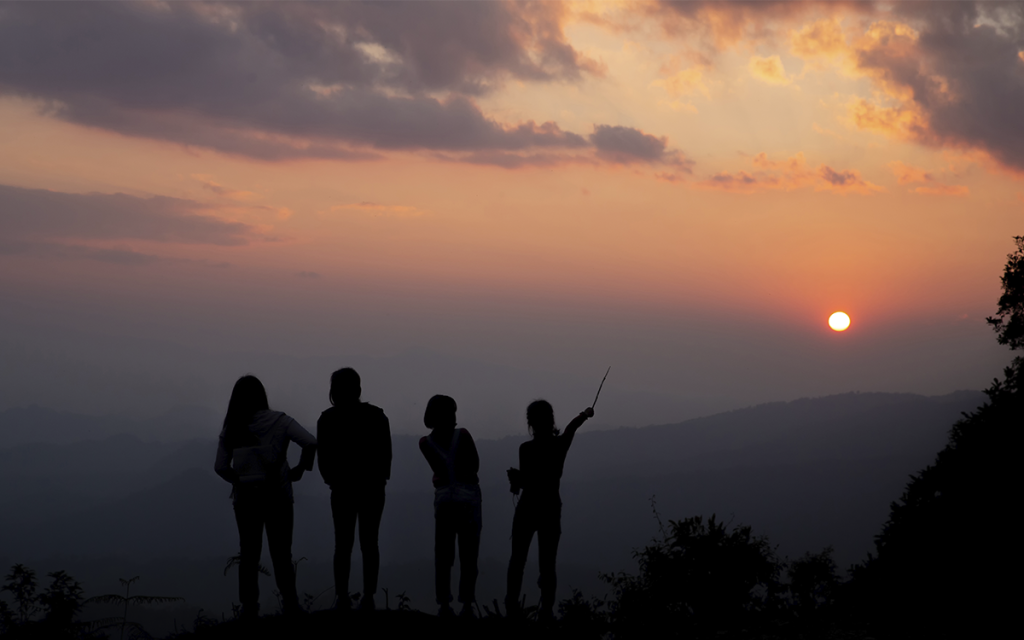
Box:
696 153 885 195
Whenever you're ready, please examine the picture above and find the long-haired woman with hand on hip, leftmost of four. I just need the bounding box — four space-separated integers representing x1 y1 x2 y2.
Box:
213 376 316 617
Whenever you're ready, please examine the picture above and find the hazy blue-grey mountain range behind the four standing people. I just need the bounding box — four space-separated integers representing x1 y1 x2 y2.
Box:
0 391 985 630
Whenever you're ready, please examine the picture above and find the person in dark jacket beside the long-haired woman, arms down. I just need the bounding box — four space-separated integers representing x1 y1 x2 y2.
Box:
316 368 391 610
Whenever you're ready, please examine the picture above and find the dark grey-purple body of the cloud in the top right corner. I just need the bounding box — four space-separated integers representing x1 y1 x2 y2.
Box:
857 2 1024 171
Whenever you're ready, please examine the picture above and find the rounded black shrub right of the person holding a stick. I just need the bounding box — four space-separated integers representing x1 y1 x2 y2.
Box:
605 515 781 638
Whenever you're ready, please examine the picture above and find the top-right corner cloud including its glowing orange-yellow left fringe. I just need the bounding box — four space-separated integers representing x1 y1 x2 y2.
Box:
778 2 1024 175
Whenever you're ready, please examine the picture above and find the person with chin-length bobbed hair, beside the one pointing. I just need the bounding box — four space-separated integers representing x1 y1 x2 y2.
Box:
420 395 482 617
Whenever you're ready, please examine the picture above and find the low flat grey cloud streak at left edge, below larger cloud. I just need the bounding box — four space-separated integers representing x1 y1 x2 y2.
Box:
0 184 257 246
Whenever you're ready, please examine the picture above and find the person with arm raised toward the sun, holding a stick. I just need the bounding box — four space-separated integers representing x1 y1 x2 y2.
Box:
505 400 594 618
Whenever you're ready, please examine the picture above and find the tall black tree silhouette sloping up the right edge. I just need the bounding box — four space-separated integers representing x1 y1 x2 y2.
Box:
854 237 1024 637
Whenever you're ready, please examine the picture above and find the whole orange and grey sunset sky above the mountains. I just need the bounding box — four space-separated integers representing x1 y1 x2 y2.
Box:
0 1 1024 435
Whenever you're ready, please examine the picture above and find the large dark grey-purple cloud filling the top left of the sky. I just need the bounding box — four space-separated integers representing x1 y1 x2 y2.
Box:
0 2 599 160
